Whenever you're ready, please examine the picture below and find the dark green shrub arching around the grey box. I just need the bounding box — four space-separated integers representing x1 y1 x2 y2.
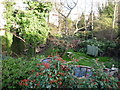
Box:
79 39 117 55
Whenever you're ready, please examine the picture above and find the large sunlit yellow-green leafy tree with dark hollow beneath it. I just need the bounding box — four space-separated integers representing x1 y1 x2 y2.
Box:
5 1 51 55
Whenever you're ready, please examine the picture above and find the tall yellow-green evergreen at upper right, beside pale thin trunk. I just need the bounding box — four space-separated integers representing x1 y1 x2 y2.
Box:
94 2 117 40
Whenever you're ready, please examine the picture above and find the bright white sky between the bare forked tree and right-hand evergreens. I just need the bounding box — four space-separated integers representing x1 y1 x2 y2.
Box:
68 0 107 20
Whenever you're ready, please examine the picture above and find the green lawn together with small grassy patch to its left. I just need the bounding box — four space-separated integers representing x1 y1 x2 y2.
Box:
39 48 120 68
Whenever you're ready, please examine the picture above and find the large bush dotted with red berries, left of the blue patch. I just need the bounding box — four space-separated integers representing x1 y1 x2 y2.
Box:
19 56 78 88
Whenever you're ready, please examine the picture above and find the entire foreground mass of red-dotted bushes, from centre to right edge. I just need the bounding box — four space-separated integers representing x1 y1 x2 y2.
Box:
19 56 118 88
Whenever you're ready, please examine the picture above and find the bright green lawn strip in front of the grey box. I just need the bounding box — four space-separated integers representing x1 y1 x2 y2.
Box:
62 50 118 68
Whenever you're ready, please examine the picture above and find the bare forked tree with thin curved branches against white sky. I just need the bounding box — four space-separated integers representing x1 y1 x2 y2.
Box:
55 0 78 35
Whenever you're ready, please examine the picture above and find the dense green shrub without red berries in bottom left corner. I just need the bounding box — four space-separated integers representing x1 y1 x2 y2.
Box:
2 57 37 88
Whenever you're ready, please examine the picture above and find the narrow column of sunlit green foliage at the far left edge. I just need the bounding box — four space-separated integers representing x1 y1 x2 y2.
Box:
3 1 15 54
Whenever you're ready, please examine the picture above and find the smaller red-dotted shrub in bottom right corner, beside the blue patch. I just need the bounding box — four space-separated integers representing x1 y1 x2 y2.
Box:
77 62 119 89
